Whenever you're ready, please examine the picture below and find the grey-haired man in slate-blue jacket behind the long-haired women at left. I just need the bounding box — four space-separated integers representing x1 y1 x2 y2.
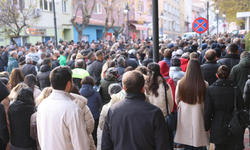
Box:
20 57 37 77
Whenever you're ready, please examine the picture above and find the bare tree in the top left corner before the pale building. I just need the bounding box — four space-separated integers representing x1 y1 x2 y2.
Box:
0 0 37 44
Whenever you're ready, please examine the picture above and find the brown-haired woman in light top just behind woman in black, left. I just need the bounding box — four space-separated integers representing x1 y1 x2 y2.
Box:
24 74 41 101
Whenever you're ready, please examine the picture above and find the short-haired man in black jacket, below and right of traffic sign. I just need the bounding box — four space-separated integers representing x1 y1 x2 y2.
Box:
201 49 220 85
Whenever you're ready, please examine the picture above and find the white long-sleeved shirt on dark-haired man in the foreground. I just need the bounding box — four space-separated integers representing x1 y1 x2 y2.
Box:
37 90 90 150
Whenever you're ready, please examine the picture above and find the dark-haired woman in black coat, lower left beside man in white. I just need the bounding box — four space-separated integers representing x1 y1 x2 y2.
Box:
9 88 36 150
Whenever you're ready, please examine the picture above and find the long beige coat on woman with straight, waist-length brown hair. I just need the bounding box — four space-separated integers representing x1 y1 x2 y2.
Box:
174 82 209 147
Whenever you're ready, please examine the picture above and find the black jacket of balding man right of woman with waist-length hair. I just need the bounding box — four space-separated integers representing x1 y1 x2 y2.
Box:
201 61 220 85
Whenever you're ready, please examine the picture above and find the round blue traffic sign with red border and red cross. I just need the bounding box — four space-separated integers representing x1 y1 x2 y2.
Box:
193 17 208 34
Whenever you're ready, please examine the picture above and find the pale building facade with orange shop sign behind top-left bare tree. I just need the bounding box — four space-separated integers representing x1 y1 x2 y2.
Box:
0 0 73 46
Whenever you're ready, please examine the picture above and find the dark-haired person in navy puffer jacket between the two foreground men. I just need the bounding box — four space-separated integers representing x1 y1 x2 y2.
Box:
79 76 102 145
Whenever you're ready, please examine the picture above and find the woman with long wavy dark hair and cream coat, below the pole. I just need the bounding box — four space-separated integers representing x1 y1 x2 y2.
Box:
145 63 174 148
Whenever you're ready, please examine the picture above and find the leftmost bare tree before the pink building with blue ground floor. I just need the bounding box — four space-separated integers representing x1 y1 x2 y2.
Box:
70 0 96 41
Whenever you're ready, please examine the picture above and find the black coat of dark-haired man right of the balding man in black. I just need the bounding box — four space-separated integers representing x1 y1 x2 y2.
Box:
217 54 240 71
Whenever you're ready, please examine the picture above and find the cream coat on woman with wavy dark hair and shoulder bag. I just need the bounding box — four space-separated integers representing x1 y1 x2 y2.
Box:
146 78 174 118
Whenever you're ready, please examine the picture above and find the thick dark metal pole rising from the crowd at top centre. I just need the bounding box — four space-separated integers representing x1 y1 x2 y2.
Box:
152 0 159 62
